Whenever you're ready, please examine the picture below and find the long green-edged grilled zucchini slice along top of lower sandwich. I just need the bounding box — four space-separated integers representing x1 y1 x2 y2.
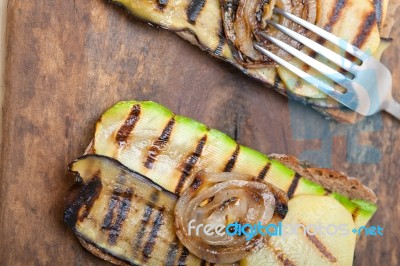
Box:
93 101 377 227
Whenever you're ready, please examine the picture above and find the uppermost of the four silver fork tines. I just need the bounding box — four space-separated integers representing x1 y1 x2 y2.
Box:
274 8 368 60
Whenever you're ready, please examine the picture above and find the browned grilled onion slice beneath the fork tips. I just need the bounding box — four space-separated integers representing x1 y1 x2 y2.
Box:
221 0 317 68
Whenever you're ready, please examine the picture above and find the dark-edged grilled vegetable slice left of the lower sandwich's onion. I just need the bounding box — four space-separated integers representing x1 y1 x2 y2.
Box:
64 155 201 265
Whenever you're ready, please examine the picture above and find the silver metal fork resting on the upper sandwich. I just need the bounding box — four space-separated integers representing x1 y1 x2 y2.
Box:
254 8 400 120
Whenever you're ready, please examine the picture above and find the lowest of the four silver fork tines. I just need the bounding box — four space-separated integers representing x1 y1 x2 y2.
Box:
254 44 346 105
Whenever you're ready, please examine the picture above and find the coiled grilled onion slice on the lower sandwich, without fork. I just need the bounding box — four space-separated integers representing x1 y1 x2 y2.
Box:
175 172 288 263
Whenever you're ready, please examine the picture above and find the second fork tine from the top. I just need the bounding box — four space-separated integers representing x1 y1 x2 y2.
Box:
263 21 358 74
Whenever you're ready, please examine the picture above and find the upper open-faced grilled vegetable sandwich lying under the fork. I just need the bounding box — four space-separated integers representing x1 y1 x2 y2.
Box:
107 0 400 123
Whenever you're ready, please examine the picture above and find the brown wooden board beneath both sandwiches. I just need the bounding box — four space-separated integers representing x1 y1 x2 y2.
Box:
0 0 400 265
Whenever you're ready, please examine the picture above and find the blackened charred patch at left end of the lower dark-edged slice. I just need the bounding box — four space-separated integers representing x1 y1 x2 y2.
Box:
64 176 103 228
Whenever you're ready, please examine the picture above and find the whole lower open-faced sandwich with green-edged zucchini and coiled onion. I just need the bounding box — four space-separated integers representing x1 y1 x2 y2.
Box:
64 101 377 265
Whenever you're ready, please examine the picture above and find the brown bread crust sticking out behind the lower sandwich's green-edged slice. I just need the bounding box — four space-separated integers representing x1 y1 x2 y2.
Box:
269 154 377 203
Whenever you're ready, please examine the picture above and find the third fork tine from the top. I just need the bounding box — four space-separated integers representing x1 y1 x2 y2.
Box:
261 33 350 84
